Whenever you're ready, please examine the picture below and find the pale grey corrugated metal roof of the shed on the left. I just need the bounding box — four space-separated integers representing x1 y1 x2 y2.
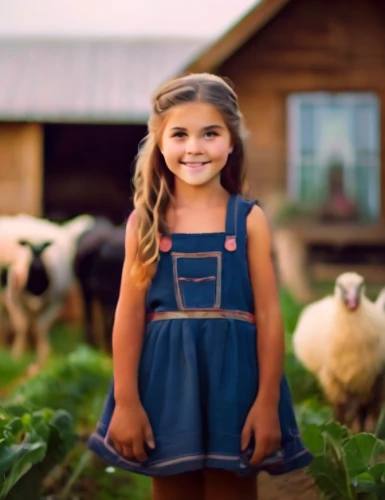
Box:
0 39 205 122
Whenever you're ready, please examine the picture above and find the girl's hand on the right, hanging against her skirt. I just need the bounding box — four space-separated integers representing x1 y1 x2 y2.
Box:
241 398 281 466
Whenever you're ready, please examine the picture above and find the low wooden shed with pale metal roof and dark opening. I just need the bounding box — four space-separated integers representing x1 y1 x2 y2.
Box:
0 39 205 223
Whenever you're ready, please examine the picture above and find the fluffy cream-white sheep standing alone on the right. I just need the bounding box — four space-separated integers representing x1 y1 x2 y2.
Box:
293 272 385 430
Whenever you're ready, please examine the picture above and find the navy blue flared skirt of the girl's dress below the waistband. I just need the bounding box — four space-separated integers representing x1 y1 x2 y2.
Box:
89 319 311 476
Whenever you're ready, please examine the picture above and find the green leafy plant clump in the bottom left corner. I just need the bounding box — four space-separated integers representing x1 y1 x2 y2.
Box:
0 346 112 500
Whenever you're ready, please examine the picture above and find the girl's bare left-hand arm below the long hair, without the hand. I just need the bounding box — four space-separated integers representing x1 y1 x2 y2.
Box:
112 212 146 405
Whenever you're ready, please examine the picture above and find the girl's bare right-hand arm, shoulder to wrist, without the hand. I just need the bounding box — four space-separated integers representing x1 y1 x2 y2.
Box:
247 206 285 406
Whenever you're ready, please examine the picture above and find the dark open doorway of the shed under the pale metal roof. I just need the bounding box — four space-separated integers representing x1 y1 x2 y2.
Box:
43 124 147 224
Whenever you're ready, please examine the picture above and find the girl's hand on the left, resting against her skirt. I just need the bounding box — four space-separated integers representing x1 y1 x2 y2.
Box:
109 401 155 462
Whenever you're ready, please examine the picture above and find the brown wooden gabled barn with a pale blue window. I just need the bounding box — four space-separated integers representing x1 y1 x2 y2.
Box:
184 0 385 283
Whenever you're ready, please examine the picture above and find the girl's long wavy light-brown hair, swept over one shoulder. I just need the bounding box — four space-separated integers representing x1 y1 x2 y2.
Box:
132 73 245 287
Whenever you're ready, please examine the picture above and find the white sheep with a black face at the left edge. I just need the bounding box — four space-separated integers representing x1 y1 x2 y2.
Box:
0 215 94 372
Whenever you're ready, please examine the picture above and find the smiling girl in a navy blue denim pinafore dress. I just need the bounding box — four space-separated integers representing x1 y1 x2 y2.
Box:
90 74 311 500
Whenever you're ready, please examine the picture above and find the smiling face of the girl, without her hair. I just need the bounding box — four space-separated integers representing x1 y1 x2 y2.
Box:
160 102 233 186
